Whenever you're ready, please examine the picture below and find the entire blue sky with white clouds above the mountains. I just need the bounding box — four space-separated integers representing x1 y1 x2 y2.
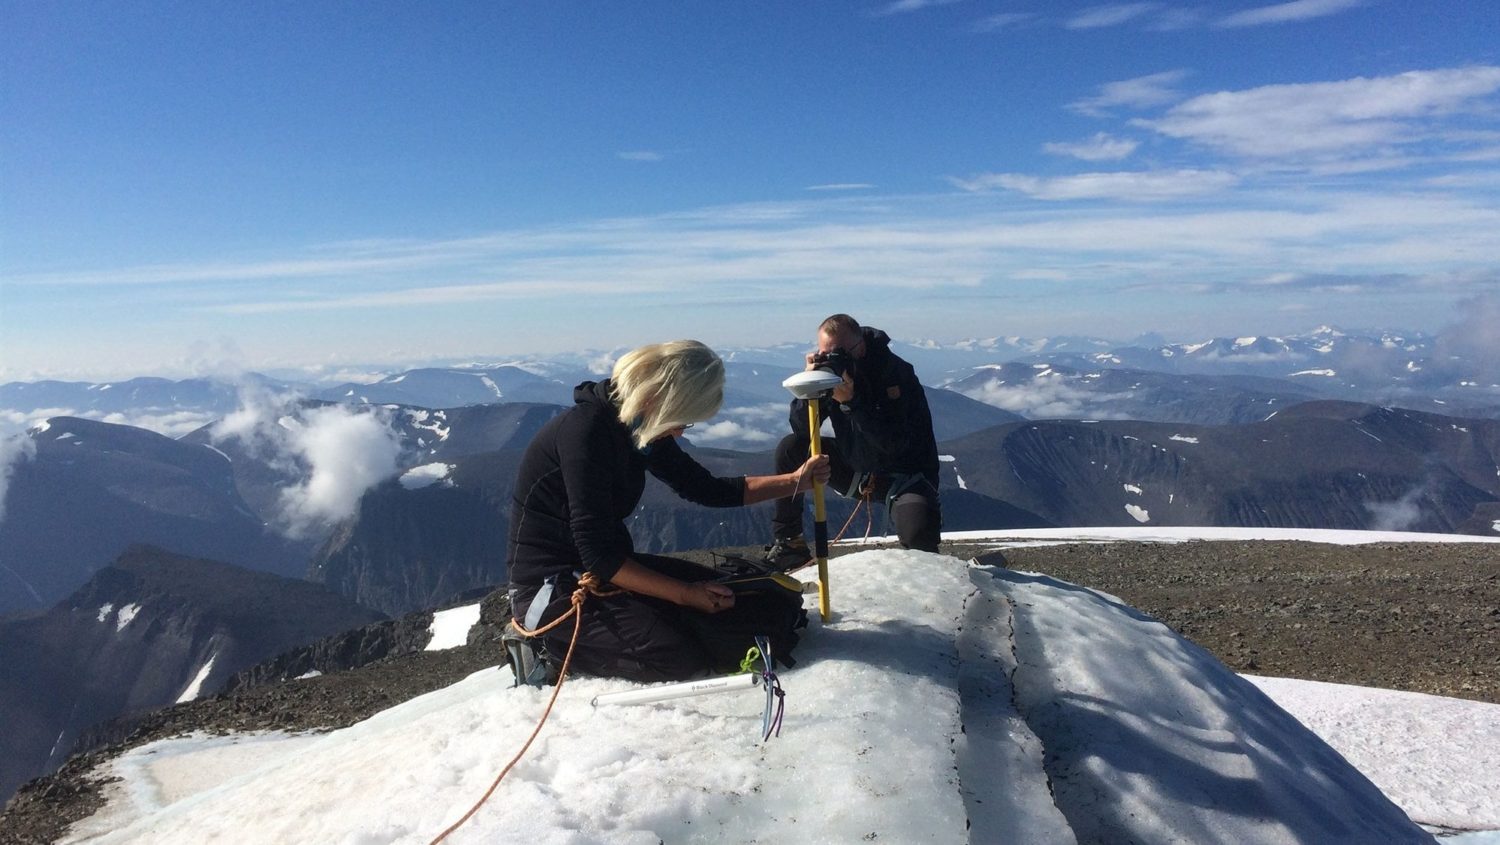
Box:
0 0 1500 380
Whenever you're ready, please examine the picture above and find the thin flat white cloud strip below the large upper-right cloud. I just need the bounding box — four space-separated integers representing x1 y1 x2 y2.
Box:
953 170 1238 203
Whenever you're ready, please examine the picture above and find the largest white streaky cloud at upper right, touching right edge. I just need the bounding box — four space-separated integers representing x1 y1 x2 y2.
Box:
1133 66 1500 158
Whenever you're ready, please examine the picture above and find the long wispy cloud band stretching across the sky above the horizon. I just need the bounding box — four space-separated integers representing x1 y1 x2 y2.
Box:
6 167 1500 328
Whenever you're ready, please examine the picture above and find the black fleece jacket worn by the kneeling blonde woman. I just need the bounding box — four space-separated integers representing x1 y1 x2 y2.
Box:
510 380 746 587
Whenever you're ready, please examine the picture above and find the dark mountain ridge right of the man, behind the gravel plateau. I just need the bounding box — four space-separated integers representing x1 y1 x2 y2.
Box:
939 402 1500 536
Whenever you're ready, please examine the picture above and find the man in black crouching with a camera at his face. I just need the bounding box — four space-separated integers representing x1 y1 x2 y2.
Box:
767 314 942 570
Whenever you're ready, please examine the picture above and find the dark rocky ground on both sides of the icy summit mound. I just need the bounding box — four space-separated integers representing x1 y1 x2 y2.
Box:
0 542 1500 843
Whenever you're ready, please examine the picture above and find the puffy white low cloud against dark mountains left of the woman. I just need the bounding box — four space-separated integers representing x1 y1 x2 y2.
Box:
282 405 401 536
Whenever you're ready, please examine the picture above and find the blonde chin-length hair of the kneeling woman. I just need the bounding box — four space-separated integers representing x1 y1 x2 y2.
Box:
609 341 725 449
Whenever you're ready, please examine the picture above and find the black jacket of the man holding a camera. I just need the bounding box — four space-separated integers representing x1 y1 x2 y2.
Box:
791 326 938 486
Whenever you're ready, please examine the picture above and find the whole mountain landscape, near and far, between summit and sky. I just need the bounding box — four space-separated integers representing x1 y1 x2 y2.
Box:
0 330 1500 794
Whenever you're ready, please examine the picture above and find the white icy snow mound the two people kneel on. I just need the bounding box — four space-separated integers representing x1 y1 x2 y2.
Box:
69 551 1458 845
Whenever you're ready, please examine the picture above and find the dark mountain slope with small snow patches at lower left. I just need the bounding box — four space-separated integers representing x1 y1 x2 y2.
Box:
0 546 381 800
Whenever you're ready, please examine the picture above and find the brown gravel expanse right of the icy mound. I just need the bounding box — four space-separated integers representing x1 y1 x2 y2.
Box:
960 542 1500 704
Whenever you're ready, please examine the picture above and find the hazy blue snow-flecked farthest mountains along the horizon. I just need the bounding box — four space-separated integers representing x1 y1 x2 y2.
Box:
11 326 1500 449
